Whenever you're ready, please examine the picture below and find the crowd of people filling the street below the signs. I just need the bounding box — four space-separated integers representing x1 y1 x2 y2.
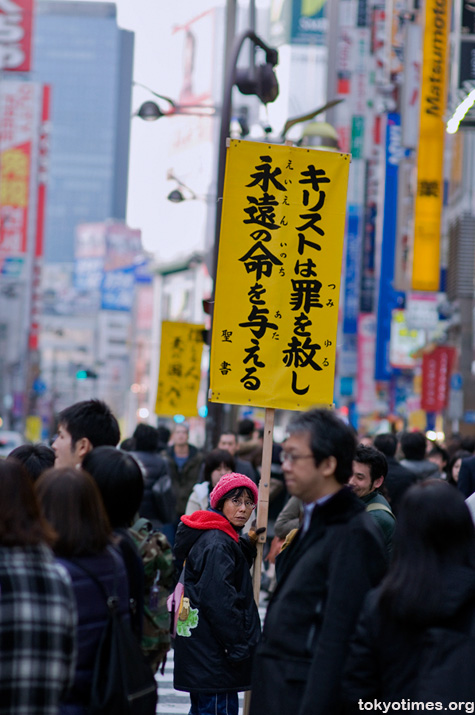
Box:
0 400 475 715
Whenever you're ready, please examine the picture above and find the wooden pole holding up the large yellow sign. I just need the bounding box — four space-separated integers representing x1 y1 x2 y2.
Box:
243 408 275 715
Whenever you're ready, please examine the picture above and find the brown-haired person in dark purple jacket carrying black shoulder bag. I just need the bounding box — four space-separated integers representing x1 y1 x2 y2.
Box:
36 467 129 715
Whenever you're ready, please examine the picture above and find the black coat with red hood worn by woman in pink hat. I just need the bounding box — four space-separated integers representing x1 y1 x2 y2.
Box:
174 511 261 693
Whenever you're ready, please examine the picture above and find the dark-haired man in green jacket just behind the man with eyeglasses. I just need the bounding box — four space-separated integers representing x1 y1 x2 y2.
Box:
348 444 396 559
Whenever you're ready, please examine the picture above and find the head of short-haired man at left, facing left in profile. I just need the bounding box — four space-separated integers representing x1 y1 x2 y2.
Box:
51 400 120 468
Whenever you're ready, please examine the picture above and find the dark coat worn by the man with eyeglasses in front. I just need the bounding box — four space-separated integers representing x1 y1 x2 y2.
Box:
251 487 386 715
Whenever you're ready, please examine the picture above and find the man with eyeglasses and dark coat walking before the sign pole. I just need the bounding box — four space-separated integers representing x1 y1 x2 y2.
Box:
250 410 386 715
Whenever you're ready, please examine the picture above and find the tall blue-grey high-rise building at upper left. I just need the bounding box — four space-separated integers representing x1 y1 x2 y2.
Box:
31 0 134 262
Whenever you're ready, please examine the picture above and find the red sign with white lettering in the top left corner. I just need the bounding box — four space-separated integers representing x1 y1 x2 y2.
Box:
0 0 33 72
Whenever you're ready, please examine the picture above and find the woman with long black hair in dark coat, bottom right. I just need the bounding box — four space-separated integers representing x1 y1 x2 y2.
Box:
343 479 475 713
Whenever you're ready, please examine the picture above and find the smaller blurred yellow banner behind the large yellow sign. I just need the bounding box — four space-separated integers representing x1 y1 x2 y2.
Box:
155 320 205 417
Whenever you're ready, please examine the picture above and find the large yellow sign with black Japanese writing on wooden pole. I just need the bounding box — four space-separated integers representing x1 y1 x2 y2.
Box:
210 140 350 410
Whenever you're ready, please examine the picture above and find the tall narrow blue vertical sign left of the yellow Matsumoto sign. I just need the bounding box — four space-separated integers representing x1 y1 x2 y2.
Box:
374 114 404 381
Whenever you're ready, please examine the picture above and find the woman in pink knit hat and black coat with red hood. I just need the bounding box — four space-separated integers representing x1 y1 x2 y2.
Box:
173 473 260 715
